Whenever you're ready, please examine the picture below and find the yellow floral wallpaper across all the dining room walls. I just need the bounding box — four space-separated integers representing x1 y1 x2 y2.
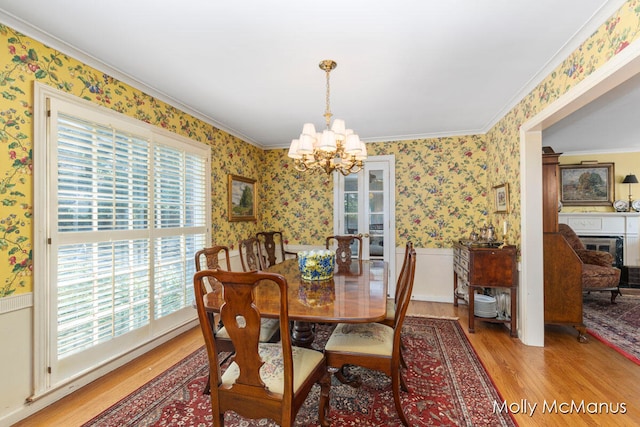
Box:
0 0 640 297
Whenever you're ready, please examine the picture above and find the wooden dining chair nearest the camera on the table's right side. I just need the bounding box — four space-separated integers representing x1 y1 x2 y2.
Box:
324 248 416 426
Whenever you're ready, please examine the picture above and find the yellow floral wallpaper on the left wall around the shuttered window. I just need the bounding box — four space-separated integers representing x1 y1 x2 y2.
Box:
0 24 264 298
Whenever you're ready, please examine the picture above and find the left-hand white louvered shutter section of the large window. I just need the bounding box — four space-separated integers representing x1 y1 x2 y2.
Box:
57 113 150 358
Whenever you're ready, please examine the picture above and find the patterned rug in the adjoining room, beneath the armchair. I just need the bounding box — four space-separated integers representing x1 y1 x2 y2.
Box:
582 289 640 365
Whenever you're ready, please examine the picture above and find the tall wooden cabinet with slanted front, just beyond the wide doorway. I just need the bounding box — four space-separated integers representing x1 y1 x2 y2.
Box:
542 147 586 342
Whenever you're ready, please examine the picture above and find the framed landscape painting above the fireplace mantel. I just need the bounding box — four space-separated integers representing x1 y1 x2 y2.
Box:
560 163 614 206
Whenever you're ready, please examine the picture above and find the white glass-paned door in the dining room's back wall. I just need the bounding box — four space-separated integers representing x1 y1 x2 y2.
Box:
333 156 395 291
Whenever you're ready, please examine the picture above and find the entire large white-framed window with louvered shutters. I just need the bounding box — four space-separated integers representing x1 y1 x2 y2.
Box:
34 85 211 394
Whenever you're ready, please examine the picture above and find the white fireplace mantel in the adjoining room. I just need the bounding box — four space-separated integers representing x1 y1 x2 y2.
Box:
558 212 640 266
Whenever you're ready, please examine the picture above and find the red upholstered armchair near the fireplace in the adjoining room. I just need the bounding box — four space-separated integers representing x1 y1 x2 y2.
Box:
558 224 620 304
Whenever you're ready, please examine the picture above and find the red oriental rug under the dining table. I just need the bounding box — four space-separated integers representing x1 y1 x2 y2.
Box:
85 317 515 427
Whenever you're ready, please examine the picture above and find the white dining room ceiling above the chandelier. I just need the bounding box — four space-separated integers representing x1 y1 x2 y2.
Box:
0 0 624 151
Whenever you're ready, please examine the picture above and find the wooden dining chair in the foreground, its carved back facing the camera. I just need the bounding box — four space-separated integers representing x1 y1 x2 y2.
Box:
193 270 330 427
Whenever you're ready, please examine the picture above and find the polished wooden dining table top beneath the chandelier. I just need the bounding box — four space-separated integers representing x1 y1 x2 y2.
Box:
205 259 388 323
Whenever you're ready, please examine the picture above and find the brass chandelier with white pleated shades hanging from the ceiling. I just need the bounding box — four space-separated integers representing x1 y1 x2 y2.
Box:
288 59 367 176
